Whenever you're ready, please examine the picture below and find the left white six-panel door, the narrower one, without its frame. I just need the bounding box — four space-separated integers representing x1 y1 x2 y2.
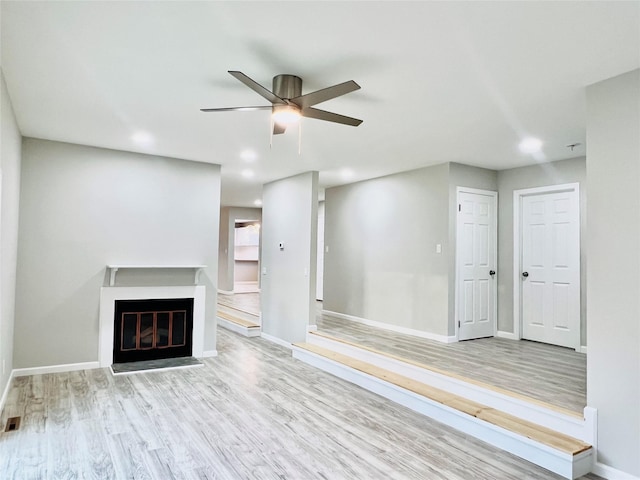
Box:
456 188 497 340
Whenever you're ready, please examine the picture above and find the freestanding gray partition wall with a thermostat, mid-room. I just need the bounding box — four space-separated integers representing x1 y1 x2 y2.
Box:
260 172 318 342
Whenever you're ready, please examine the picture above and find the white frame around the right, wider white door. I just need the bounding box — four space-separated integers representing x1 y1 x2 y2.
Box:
513 182 582 351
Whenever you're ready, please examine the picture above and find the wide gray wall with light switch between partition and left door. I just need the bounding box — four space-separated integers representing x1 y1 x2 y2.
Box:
323 164 449 335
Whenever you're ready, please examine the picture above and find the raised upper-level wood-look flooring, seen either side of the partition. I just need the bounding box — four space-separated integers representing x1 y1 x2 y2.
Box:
218 294 587 413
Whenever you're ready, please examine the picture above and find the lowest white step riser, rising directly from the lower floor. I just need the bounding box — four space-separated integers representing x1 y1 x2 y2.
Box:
293 346 593 479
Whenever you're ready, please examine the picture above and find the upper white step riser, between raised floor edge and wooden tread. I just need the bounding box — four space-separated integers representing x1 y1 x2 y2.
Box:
307 334 596 446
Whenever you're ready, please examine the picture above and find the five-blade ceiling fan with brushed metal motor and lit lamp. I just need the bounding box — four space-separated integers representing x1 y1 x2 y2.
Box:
200 70 362 135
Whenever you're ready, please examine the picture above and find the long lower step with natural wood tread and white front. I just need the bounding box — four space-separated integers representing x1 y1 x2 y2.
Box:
293 343 593 479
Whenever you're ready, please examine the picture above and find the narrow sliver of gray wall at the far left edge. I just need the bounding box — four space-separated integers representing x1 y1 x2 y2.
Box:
0 71 22 396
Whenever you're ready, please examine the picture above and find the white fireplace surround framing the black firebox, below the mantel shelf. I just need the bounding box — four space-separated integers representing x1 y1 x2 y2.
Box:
98 285 206 367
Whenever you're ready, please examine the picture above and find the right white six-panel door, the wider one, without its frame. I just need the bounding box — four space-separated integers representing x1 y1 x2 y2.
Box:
520 189 580 348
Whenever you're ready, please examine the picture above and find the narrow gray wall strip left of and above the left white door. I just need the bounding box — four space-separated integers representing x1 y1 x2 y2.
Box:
448 163 500 335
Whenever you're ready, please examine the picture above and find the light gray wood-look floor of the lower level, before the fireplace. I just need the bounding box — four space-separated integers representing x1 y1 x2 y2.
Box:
0 328 598 480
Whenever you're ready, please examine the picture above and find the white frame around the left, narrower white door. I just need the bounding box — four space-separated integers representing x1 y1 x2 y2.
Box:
453 187 499 342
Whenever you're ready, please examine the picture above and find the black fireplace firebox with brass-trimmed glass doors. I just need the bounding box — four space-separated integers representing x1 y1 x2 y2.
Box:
113 298 194 363
